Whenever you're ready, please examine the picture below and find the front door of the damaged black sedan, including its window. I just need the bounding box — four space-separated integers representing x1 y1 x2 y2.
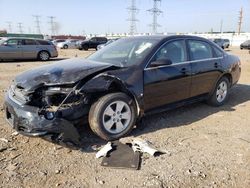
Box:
144 40 191 111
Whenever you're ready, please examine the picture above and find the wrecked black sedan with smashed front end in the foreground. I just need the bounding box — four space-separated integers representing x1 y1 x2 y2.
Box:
5 36 241 140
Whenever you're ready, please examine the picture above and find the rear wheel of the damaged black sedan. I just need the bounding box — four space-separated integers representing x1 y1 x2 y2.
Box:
208 77 230 106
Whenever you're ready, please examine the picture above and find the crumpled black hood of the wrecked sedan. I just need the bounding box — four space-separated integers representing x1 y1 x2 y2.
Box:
15 58 113 91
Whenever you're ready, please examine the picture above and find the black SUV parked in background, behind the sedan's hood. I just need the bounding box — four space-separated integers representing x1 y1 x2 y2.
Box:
78 37 108 50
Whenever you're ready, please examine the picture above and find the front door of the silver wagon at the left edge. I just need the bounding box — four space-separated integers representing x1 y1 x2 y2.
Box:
0 39 22 59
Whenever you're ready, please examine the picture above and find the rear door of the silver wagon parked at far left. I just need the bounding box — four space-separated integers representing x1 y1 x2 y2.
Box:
21 39 38 59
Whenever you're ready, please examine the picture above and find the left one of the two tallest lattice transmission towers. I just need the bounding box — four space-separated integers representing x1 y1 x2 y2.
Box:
127 0 139 35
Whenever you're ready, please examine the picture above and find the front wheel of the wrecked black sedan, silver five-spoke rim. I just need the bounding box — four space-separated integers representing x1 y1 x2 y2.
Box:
89 93 137 140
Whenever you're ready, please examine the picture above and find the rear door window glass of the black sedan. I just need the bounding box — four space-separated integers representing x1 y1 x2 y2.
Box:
188 40 213 61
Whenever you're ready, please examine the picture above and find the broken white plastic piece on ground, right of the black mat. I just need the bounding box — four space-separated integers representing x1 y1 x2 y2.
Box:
132 138 165 156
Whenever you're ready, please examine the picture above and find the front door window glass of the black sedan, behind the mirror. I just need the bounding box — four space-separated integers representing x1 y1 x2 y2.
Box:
153 40 187 63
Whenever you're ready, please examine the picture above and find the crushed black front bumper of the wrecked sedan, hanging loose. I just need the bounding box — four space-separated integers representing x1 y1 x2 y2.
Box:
4 93 79 138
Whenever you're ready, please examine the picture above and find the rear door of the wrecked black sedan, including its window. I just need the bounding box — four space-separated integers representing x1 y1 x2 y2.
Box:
187 39 223 97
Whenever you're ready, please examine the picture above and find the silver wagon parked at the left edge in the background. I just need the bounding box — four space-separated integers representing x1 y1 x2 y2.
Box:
0 38 58 61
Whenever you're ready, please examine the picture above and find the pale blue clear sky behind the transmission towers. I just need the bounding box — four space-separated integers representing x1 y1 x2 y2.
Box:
0 0 250 35
